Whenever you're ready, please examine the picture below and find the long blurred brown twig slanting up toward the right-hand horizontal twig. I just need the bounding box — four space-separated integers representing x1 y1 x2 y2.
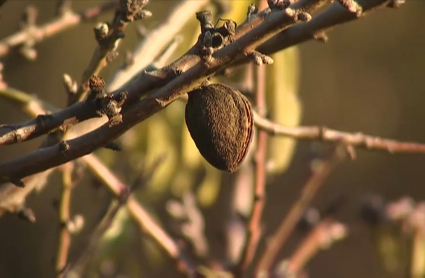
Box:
256 145 346 277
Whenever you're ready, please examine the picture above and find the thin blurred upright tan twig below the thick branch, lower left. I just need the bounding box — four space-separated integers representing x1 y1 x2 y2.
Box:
56 163 73 277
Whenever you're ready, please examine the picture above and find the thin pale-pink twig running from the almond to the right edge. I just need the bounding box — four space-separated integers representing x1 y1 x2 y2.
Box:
254 112 425 154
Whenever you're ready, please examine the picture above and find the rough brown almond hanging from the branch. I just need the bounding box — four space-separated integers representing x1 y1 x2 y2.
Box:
185 84 253 172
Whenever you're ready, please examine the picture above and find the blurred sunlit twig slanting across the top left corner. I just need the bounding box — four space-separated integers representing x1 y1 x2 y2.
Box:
0 1 118 58
